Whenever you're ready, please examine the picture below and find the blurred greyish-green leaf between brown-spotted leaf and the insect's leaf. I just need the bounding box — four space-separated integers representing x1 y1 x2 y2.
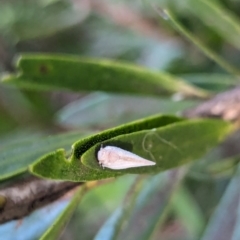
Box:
56 92 198 129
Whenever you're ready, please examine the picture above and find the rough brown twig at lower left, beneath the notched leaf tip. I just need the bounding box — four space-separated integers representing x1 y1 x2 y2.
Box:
0 176 82 223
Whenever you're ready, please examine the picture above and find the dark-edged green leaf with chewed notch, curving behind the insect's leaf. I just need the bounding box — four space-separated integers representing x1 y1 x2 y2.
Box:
30 115 183 181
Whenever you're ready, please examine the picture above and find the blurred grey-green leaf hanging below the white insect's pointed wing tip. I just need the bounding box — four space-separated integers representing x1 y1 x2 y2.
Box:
119 169 185 240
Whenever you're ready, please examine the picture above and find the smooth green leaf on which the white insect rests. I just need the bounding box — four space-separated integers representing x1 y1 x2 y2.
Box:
81 120 230 173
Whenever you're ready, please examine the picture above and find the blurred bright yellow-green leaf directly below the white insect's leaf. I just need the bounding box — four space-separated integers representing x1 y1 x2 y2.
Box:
66 175 139 240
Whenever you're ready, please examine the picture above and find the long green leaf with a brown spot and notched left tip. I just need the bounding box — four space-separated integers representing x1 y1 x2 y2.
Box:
3 54 208 97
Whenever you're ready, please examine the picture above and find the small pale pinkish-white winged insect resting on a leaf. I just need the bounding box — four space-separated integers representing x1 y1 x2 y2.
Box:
97 146 156 170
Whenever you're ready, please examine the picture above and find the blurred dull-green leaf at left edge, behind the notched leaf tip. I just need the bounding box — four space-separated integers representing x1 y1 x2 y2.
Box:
0 132 92 180
